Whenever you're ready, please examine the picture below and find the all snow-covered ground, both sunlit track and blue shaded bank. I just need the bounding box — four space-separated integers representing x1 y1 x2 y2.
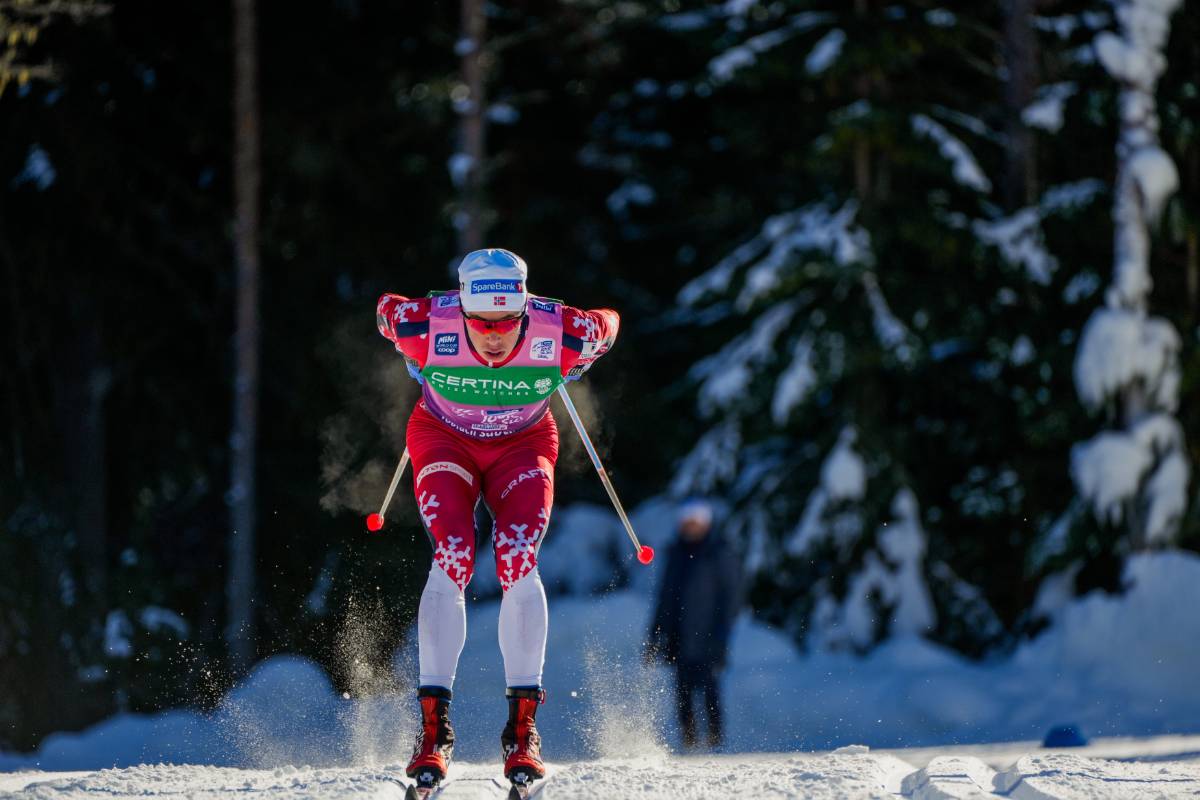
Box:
0 510 1200 800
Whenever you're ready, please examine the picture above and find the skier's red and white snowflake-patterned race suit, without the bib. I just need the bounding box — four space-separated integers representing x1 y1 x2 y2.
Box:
376 294 620 688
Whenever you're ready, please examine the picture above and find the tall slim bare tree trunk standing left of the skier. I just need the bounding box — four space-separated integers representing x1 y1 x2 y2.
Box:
226 0 260 675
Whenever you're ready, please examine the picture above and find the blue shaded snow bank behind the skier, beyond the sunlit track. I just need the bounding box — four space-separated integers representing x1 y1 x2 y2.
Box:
0 532 1200 767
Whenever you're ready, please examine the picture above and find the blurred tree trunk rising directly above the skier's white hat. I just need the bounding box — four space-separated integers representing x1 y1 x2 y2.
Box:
456 0 487 254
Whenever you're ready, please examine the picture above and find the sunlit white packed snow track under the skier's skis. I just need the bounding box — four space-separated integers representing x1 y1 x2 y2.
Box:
0 747 1200 800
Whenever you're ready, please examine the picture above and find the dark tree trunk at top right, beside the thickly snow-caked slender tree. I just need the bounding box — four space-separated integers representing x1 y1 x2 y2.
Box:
1003 0 1038 211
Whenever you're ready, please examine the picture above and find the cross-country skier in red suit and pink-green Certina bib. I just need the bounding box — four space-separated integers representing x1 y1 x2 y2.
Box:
376 249 619 787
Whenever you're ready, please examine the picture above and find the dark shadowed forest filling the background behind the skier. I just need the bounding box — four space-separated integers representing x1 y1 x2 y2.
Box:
0 0 1200 748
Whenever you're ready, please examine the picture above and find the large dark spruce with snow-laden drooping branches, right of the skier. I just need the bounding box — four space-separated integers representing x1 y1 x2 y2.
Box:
583 2 1176 651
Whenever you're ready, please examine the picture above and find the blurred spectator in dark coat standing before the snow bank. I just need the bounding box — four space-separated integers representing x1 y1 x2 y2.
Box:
646 500 742 747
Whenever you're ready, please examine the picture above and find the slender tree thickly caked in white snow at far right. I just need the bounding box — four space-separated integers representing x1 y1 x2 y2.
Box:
1065 0 1190 549
